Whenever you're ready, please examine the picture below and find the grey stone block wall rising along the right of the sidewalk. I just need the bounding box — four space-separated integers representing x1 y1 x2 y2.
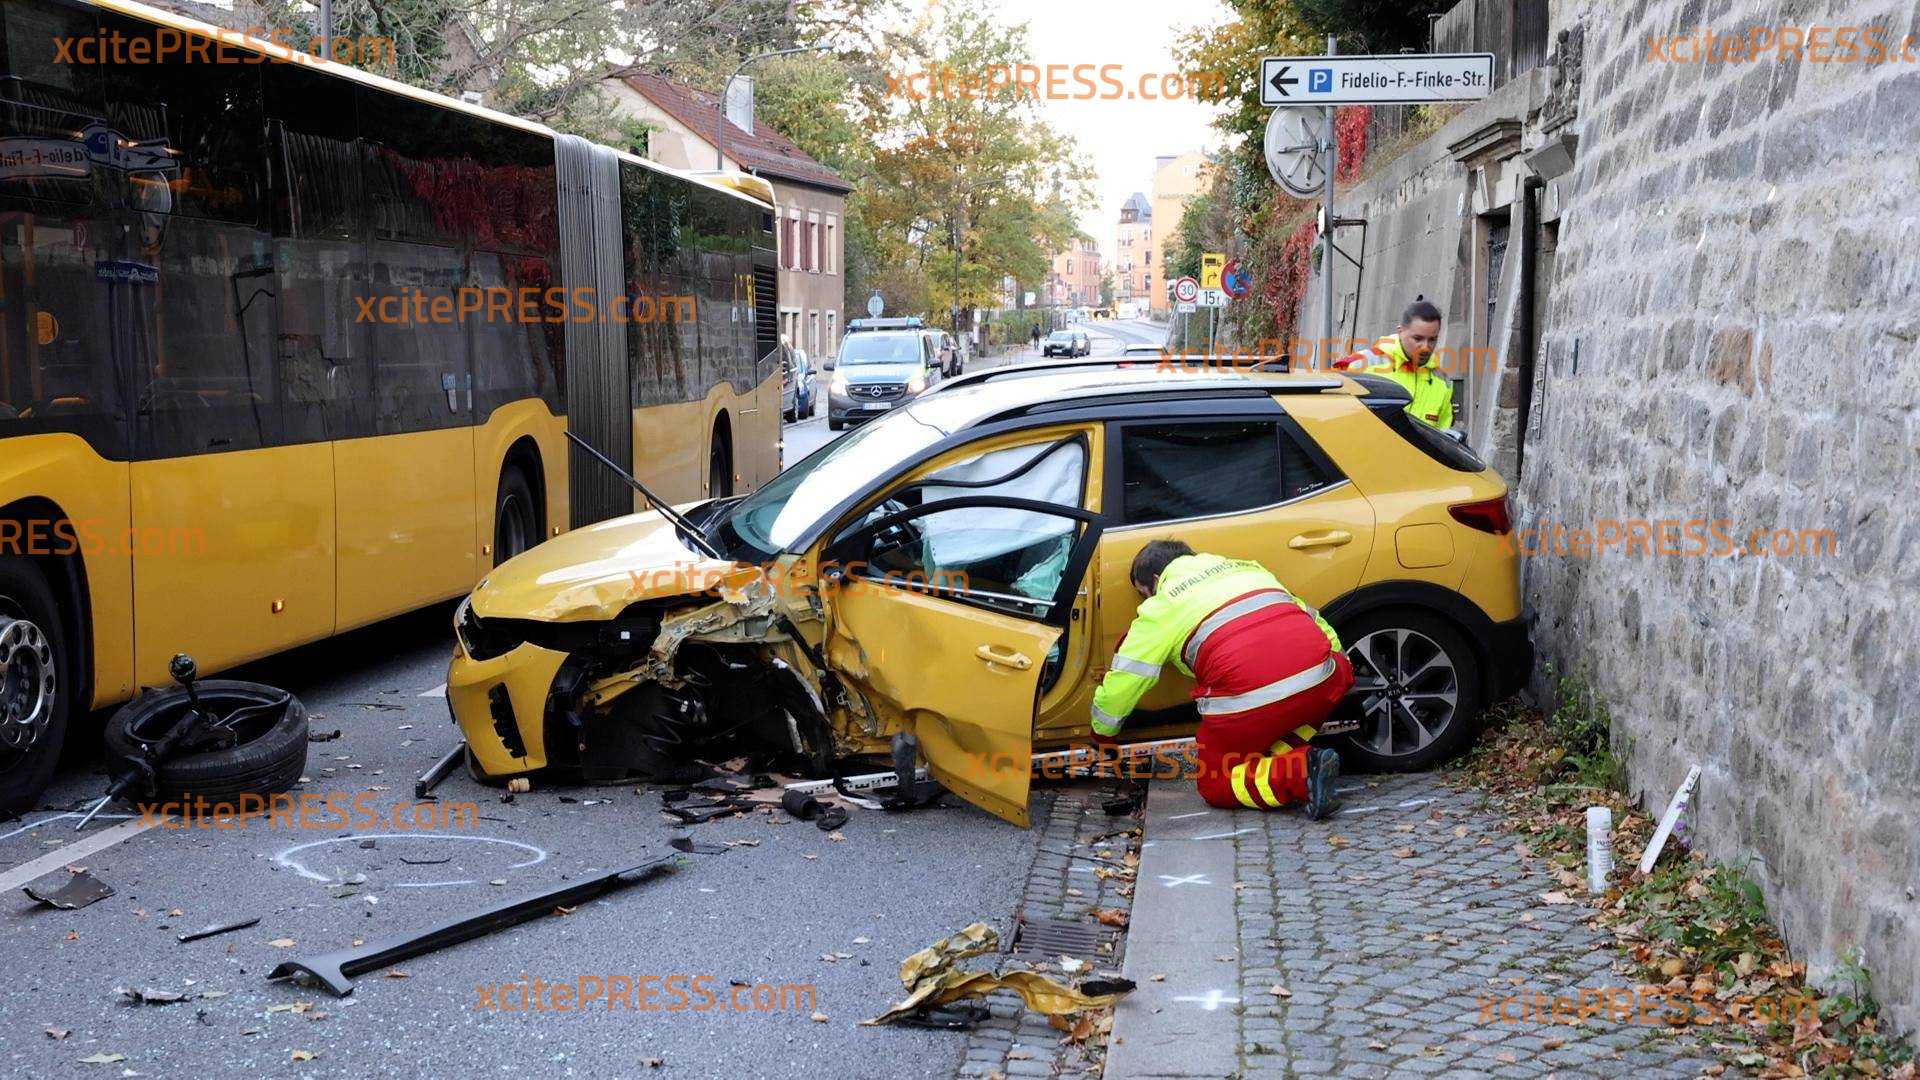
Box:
1521 0 1920 1028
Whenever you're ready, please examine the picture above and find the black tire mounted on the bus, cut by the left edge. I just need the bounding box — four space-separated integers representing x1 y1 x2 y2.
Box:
0 557 70 815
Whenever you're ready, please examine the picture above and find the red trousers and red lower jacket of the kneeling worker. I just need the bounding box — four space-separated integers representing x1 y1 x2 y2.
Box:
1194 645 1354 809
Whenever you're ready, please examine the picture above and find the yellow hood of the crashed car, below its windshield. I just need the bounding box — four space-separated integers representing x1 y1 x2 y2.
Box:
472 507 755 623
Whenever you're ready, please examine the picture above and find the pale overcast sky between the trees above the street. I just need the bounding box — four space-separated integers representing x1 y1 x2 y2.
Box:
1013 0 1229 249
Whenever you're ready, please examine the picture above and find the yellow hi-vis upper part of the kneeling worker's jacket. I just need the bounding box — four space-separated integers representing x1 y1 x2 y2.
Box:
1092 553 1340 736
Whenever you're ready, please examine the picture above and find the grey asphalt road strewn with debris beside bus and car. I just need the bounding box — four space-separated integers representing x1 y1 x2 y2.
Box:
0 323 1154 1078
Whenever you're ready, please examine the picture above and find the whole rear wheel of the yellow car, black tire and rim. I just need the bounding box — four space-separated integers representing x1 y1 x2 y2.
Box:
1329 607 1486 773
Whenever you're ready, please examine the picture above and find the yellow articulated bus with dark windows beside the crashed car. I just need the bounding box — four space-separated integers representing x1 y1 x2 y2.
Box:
0 0 780 811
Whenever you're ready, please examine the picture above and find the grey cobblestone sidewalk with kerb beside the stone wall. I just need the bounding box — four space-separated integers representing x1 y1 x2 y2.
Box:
1108 774 1716 1078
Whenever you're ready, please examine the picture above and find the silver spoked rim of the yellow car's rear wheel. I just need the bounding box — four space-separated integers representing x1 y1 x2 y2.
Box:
1346 628 1459 757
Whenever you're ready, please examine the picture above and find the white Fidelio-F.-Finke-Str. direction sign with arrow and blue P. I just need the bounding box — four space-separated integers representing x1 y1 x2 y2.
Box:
1260 52 1494 106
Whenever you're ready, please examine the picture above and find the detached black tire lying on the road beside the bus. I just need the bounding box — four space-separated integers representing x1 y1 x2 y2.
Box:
106 678 307 801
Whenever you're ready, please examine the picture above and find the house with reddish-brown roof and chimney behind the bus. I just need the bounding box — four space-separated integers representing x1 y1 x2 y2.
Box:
609 75 852 357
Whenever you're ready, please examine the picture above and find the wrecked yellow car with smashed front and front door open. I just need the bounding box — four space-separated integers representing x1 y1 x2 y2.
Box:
447 359 1532 824
